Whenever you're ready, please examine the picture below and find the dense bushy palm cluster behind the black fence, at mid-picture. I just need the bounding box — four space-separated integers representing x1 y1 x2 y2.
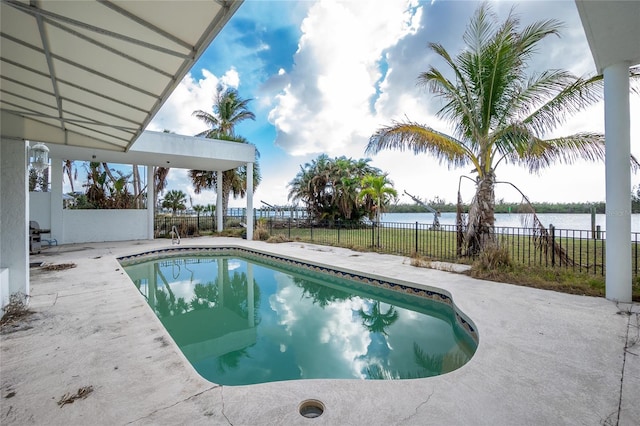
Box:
289 154 391 221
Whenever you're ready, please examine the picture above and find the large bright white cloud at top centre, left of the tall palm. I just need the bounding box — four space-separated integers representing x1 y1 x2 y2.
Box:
269 1 420 156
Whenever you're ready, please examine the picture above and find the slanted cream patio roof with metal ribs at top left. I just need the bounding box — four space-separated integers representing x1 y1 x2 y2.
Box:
0 0 243 151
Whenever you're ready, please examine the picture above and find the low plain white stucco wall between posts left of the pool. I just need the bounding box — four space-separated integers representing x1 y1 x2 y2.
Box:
62 209 148 244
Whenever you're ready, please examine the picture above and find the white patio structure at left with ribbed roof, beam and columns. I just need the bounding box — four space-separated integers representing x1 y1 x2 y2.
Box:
0 0 246 306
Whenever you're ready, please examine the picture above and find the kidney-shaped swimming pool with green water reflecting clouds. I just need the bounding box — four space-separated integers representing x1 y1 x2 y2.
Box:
119 247 478 385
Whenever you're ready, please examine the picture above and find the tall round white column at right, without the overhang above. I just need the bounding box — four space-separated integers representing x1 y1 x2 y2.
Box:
603 63 632 302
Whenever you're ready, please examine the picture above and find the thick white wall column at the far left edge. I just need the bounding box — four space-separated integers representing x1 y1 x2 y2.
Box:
0 139 30 300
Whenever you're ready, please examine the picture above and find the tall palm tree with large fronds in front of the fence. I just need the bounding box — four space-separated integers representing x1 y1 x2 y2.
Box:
366 4 636 252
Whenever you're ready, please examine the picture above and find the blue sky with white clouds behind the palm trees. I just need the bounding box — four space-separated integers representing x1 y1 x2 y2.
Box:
147 0 640 207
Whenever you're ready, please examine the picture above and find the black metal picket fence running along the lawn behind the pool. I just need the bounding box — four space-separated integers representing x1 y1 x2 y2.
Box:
154 215 640 277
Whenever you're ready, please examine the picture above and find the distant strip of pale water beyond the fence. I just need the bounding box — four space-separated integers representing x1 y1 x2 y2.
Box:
382 212 640 232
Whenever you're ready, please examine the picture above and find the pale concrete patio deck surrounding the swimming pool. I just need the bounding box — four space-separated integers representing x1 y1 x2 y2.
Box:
0 237 640 426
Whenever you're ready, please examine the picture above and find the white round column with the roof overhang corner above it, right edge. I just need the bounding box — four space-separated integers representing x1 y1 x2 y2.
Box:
575 0 640 302
